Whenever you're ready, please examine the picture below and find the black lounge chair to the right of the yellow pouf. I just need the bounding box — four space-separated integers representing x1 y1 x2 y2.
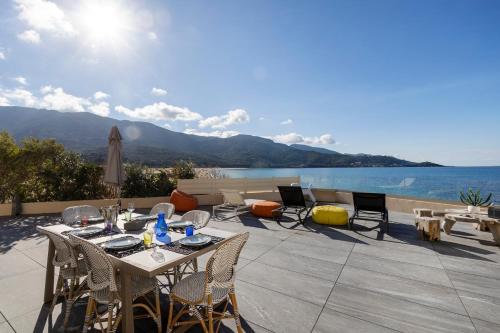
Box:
349 192 389 232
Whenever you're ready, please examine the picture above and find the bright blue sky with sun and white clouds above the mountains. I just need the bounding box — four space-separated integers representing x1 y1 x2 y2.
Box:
0 0 500 166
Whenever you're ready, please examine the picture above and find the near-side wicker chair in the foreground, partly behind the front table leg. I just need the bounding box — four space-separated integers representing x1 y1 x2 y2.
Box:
69 235 161 333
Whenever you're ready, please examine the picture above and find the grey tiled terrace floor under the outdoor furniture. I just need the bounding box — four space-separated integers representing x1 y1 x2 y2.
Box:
0 204 500 333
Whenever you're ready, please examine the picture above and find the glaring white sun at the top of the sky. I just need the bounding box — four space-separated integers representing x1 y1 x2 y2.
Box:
78 0 132 47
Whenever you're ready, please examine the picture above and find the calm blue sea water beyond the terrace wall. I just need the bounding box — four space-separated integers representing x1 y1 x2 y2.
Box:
222 167 500 203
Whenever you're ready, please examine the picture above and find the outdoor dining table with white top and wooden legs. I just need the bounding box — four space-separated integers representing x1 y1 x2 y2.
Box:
37 214 236 333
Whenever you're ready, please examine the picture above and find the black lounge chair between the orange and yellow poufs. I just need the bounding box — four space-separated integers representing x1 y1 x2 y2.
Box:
273 186 316 224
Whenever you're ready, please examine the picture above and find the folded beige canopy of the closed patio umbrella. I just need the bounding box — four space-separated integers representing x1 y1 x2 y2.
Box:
104 126 125 197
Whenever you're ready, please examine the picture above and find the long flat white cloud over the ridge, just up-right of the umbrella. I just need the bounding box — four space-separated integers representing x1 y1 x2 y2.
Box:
115 102 202 121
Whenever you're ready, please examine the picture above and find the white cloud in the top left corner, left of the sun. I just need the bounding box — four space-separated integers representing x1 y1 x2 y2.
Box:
14 0 76 36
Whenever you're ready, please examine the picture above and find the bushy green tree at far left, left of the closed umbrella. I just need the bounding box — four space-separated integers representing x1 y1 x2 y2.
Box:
0 132 107 203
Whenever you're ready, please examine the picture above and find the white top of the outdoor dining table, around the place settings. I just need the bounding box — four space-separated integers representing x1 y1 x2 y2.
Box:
38 214 236 276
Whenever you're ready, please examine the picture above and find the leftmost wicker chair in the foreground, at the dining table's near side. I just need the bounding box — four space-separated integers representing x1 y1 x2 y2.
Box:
40 230 88 328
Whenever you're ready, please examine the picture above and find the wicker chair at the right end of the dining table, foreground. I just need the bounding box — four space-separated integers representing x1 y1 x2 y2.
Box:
167 232 249 333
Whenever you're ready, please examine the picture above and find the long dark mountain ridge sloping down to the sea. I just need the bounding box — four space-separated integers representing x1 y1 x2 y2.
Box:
0 106 436 167
